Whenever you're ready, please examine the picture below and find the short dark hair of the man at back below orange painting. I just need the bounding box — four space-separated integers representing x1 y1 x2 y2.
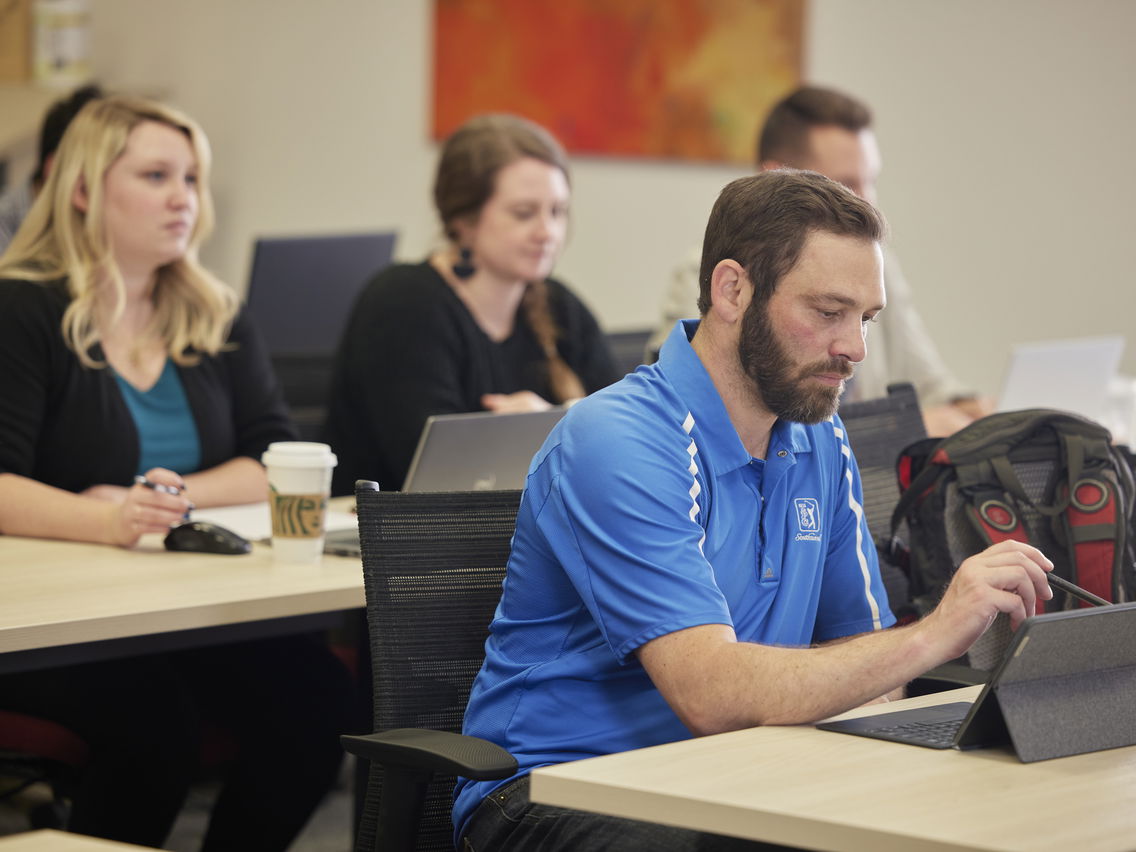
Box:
757 86 871 167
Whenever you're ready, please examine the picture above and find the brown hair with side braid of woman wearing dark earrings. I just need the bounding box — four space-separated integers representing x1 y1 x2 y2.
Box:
434 114 586 402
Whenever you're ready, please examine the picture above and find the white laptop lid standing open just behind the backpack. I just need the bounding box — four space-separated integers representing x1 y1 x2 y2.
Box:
997 335 1125 423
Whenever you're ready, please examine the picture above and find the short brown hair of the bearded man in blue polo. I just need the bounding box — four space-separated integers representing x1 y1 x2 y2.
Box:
699 168 887 316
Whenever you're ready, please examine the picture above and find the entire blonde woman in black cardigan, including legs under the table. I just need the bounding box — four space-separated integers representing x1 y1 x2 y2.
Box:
0 97 352 850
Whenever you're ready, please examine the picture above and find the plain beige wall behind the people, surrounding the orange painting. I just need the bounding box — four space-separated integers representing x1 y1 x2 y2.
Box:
88 0 1136 391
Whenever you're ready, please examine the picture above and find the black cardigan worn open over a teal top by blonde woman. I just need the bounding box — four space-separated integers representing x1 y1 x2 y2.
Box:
0 281 295 492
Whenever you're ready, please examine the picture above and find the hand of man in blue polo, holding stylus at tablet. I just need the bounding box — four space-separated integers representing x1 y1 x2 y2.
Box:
918 541 1053 659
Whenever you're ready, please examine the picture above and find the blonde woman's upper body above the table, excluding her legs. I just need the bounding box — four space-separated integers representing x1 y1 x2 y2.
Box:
0 98 293 545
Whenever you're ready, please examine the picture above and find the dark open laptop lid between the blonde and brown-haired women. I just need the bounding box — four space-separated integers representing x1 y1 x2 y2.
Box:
247 232 395 358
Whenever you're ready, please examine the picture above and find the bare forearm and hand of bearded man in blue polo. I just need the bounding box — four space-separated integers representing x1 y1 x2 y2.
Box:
637 541 1053 734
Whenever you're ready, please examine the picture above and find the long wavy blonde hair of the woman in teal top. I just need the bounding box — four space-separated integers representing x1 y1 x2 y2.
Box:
0 95 239 367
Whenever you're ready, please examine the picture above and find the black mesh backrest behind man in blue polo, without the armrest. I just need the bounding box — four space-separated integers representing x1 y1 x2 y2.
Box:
356 483 520 850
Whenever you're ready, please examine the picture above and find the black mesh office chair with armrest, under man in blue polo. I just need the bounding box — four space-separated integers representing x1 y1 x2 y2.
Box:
342 482 520 852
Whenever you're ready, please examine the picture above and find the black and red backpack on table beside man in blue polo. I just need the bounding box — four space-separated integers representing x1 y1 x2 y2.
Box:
892 409 1136 615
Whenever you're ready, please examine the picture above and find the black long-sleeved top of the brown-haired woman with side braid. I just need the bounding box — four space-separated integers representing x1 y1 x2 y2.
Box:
327 262 618 494
